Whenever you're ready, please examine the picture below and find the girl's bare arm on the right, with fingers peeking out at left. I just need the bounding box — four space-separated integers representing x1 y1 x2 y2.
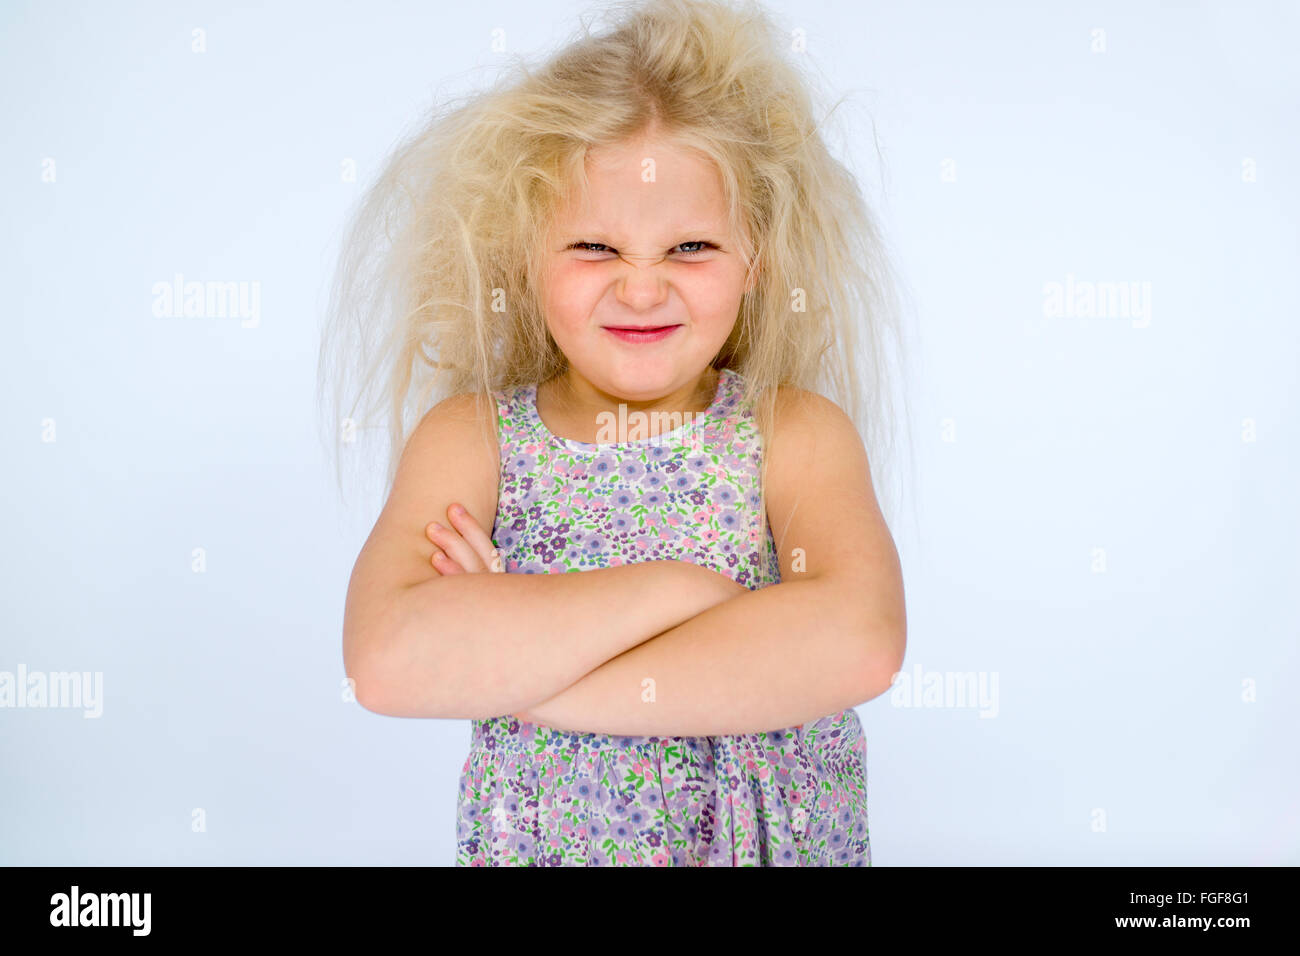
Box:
416 397 906 736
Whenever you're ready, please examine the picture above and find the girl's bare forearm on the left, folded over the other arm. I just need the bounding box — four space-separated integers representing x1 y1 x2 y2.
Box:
358 561 745 719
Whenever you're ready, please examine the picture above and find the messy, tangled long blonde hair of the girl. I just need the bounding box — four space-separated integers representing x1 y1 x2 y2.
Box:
320 0 905 541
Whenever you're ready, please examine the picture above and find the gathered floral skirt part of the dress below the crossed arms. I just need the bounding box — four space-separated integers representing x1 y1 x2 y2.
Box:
456 709 871 866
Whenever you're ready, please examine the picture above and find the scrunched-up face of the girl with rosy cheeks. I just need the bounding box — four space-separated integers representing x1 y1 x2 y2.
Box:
543 138 746 402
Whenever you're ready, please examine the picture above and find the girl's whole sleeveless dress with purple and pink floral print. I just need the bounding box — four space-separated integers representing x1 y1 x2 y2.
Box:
456 368 871 866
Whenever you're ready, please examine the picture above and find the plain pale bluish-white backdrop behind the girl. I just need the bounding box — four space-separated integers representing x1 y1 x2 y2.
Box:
0 0 1300 866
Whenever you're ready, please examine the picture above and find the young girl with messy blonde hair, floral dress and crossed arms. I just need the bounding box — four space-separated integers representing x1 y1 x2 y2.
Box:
322 0 906 866
